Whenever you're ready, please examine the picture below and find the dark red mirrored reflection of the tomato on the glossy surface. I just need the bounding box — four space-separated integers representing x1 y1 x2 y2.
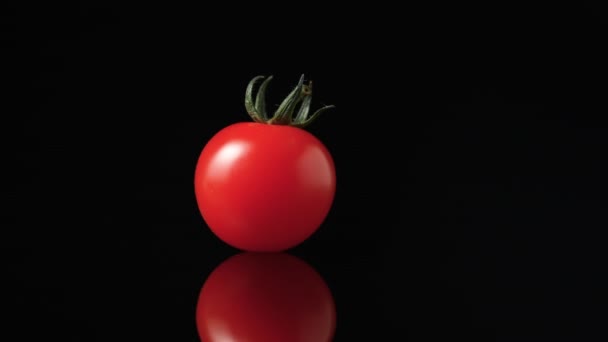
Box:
196 252 336 342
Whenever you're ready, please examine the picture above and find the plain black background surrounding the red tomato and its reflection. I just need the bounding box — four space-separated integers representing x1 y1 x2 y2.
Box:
0 2 608 341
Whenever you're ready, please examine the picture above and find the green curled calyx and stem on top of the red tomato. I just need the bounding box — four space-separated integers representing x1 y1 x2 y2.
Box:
245 75 334 128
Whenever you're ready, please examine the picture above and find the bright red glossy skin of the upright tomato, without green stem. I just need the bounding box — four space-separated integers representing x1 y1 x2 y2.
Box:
194 122 336 252
